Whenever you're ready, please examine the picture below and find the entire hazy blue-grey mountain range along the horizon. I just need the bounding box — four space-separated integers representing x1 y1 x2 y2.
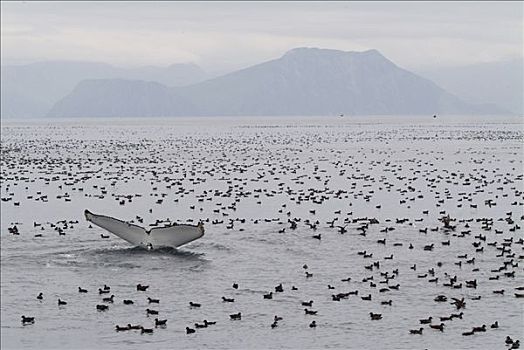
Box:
1 48 522 118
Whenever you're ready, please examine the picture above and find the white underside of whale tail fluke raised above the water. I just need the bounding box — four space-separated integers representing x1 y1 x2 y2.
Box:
84 209 204 249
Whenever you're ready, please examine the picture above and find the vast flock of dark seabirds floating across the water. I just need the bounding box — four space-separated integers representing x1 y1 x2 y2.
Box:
1 120 524 349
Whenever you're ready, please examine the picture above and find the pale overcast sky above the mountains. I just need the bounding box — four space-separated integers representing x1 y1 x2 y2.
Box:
0 1 523 71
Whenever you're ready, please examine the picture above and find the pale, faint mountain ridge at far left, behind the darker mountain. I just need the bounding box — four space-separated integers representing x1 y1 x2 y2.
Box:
1 61 209 118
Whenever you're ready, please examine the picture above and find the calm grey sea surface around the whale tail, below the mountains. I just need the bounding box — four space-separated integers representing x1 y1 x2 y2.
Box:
0 117 524 349
